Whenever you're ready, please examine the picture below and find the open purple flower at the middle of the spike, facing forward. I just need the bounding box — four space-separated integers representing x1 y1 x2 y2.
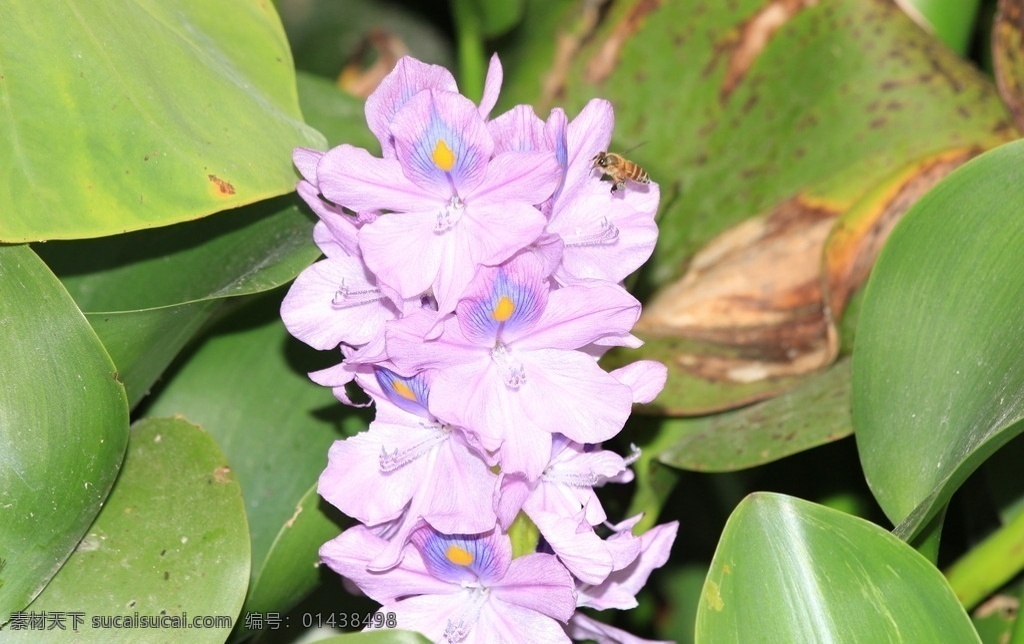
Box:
385 250 640 479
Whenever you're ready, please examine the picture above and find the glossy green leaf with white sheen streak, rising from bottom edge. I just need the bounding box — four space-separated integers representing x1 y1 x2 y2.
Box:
696 492 980 644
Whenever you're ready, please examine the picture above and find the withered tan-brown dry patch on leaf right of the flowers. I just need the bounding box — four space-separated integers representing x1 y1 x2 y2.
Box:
636 190 840 383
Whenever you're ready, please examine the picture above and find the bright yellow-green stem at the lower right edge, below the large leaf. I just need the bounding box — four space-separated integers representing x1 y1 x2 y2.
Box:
946 512 1024 610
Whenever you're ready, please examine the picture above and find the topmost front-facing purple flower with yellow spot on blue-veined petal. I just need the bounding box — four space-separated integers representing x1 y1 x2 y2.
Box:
317 89 560 313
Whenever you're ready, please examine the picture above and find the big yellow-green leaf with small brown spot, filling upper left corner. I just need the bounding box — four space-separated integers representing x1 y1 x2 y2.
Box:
0 0 324 242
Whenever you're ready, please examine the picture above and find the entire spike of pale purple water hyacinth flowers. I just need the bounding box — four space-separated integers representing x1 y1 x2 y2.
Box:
282 57 677 642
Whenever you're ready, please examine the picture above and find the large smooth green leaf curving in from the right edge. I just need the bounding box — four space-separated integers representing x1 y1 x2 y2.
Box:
853 141 1024 538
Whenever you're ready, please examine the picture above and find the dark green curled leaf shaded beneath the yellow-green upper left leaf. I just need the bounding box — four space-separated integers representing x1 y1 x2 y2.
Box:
38 195 319 406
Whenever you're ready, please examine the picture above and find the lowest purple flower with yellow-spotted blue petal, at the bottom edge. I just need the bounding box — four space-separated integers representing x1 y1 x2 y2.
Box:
319 526 575 643
